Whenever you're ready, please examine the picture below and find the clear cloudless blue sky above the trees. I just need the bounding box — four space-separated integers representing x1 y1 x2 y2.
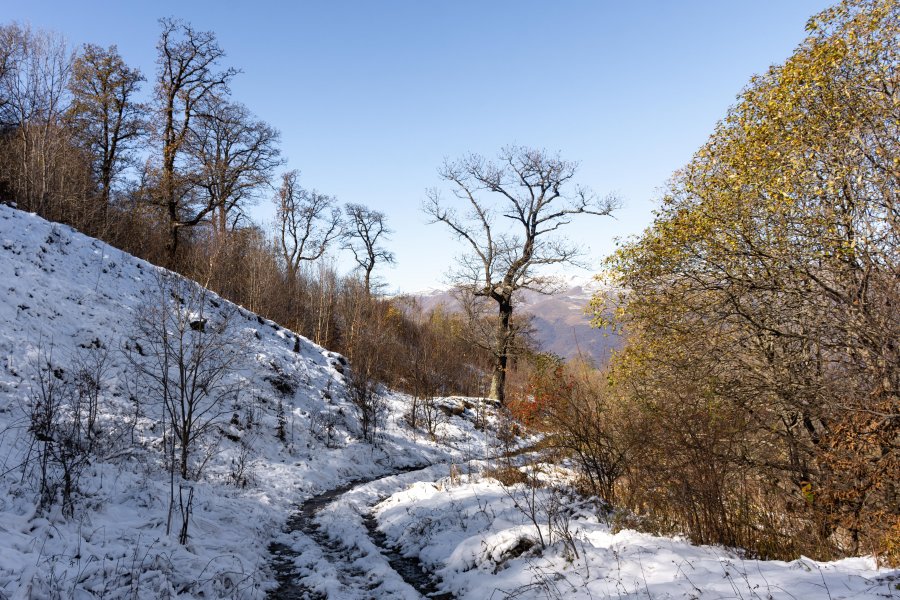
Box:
10 0 831 291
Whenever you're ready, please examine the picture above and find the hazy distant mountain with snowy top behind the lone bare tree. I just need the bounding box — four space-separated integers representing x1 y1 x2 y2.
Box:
412 278 621 365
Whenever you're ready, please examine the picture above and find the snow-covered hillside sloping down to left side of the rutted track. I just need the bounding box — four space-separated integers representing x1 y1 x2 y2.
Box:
0 205 486 598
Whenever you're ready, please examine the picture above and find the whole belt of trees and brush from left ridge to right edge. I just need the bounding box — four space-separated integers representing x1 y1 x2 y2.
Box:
0 0 900 597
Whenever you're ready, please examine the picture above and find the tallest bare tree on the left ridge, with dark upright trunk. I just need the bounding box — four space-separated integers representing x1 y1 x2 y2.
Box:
156 18 237 263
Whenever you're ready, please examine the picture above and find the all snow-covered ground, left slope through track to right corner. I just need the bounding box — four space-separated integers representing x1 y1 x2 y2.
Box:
0 205 900 600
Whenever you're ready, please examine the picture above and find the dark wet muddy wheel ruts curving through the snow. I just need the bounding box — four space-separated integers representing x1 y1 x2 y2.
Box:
268 466 454 600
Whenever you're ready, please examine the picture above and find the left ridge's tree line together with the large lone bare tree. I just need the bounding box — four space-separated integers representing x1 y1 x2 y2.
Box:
0 18 617 402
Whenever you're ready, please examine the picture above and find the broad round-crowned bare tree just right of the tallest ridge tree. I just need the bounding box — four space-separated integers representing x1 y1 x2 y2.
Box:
188 96 282 235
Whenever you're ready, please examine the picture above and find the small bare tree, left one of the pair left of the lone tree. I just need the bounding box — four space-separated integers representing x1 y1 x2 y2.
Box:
274 170 341 281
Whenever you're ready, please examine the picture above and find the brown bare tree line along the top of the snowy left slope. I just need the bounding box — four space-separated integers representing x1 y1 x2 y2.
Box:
0 18 502 393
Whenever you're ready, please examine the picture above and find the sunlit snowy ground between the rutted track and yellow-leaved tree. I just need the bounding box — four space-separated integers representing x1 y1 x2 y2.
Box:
375 462 900 600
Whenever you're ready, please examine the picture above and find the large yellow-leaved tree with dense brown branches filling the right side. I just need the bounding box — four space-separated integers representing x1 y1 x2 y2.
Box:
595 0 900 563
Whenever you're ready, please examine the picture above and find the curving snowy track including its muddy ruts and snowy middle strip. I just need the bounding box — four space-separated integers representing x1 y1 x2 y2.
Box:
269 465 453 600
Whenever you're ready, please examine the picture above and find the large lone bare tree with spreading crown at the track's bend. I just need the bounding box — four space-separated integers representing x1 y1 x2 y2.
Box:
424 146 618 402
